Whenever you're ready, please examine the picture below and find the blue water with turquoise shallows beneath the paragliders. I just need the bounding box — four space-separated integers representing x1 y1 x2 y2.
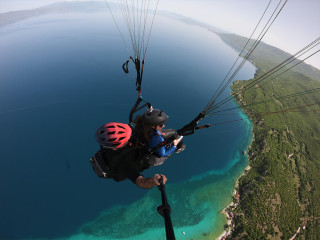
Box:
0 5 256 240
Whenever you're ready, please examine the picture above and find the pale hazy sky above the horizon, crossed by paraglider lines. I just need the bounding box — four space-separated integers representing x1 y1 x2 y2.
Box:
0 0 320 69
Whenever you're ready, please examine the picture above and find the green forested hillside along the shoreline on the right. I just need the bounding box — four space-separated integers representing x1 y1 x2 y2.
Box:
219 34 320 240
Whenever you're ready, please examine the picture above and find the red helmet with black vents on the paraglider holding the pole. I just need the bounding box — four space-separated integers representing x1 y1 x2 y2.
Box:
95 122 132 148
